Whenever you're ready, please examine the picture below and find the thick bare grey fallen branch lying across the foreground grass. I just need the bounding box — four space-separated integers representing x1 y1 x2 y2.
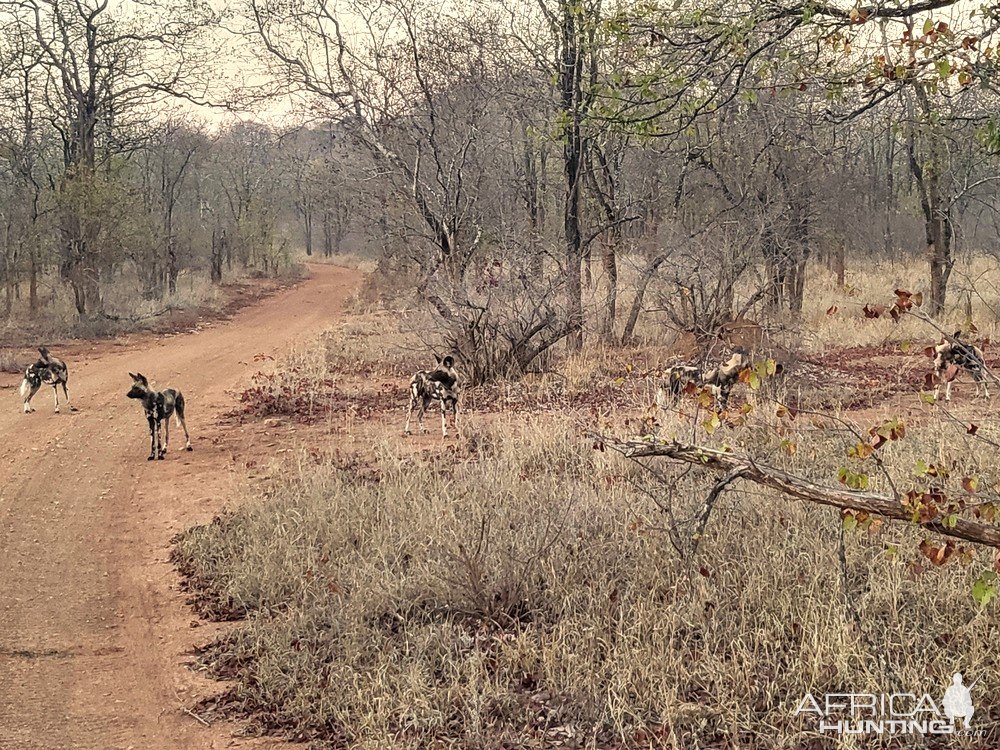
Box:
599 436 1000 548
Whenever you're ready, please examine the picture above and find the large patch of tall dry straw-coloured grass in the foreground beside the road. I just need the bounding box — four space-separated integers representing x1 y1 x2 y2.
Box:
176 412 1000 748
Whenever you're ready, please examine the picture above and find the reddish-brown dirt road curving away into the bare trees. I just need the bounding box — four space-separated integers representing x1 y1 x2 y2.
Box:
0 266 358 750
